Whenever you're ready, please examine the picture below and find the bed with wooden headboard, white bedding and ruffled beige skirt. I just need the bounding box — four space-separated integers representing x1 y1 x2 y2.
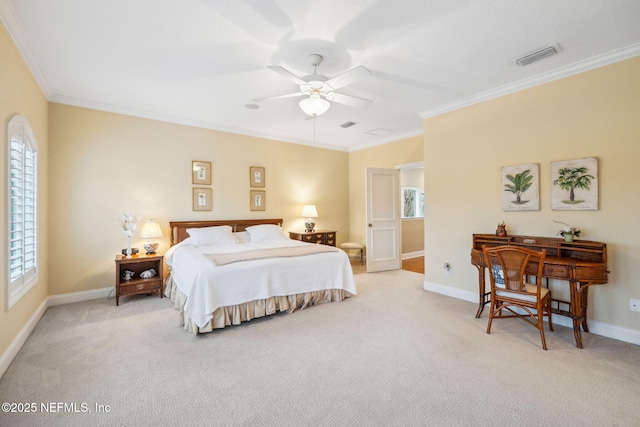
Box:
165 219 357 334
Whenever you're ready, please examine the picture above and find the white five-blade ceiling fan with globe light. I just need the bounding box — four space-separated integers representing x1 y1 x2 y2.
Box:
254 53 373 117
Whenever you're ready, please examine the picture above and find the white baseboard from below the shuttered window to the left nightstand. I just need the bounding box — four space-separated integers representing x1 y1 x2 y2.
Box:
0 287 114 378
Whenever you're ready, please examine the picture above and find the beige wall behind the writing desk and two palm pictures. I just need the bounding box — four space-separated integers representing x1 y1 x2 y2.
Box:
424 57 640 330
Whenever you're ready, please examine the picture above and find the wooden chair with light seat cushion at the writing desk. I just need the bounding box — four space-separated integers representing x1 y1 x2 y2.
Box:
482 246 553 350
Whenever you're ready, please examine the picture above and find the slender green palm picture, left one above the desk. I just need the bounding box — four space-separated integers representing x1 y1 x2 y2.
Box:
500 163 540 212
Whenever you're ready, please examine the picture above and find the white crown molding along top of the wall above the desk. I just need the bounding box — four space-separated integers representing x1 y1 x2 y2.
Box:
420 43 640 120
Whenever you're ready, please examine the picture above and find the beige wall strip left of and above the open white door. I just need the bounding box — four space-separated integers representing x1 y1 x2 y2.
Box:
349 136 423 249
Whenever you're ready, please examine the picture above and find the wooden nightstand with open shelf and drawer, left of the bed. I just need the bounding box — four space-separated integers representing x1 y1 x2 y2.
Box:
116 254 164 305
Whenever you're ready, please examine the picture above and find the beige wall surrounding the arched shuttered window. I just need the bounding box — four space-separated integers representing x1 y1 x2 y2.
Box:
0 25 49 358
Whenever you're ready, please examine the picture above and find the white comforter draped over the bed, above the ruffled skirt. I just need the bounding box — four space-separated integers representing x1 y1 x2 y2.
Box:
165 239 357 327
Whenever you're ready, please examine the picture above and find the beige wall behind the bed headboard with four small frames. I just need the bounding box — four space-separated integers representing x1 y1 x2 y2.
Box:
49 104 349 295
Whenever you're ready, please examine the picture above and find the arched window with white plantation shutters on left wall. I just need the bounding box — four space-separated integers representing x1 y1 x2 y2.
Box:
7 116 38 308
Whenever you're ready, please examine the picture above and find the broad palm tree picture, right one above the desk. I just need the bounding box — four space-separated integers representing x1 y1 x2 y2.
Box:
551 157 598 211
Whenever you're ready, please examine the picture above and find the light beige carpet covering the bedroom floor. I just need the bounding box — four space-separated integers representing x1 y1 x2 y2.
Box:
0 270 640 426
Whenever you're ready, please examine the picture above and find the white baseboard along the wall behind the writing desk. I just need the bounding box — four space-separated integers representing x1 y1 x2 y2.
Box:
423 280 640 345
